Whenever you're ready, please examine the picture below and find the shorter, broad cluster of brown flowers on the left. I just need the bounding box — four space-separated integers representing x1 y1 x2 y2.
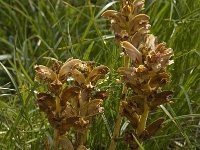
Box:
35 59 109 147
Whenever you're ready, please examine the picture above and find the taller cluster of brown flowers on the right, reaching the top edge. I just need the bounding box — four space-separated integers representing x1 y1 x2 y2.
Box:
103 0 173 149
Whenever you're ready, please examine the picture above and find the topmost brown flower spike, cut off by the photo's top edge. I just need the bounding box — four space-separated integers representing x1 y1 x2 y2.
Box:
102 0 150 48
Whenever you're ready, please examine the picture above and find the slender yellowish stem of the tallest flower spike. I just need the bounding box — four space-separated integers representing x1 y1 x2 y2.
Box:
108 56 129 150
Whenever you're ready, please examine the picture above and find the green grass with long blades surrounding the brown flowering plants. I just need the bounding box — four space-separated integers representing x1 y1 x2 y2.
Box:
0 0 200 150
